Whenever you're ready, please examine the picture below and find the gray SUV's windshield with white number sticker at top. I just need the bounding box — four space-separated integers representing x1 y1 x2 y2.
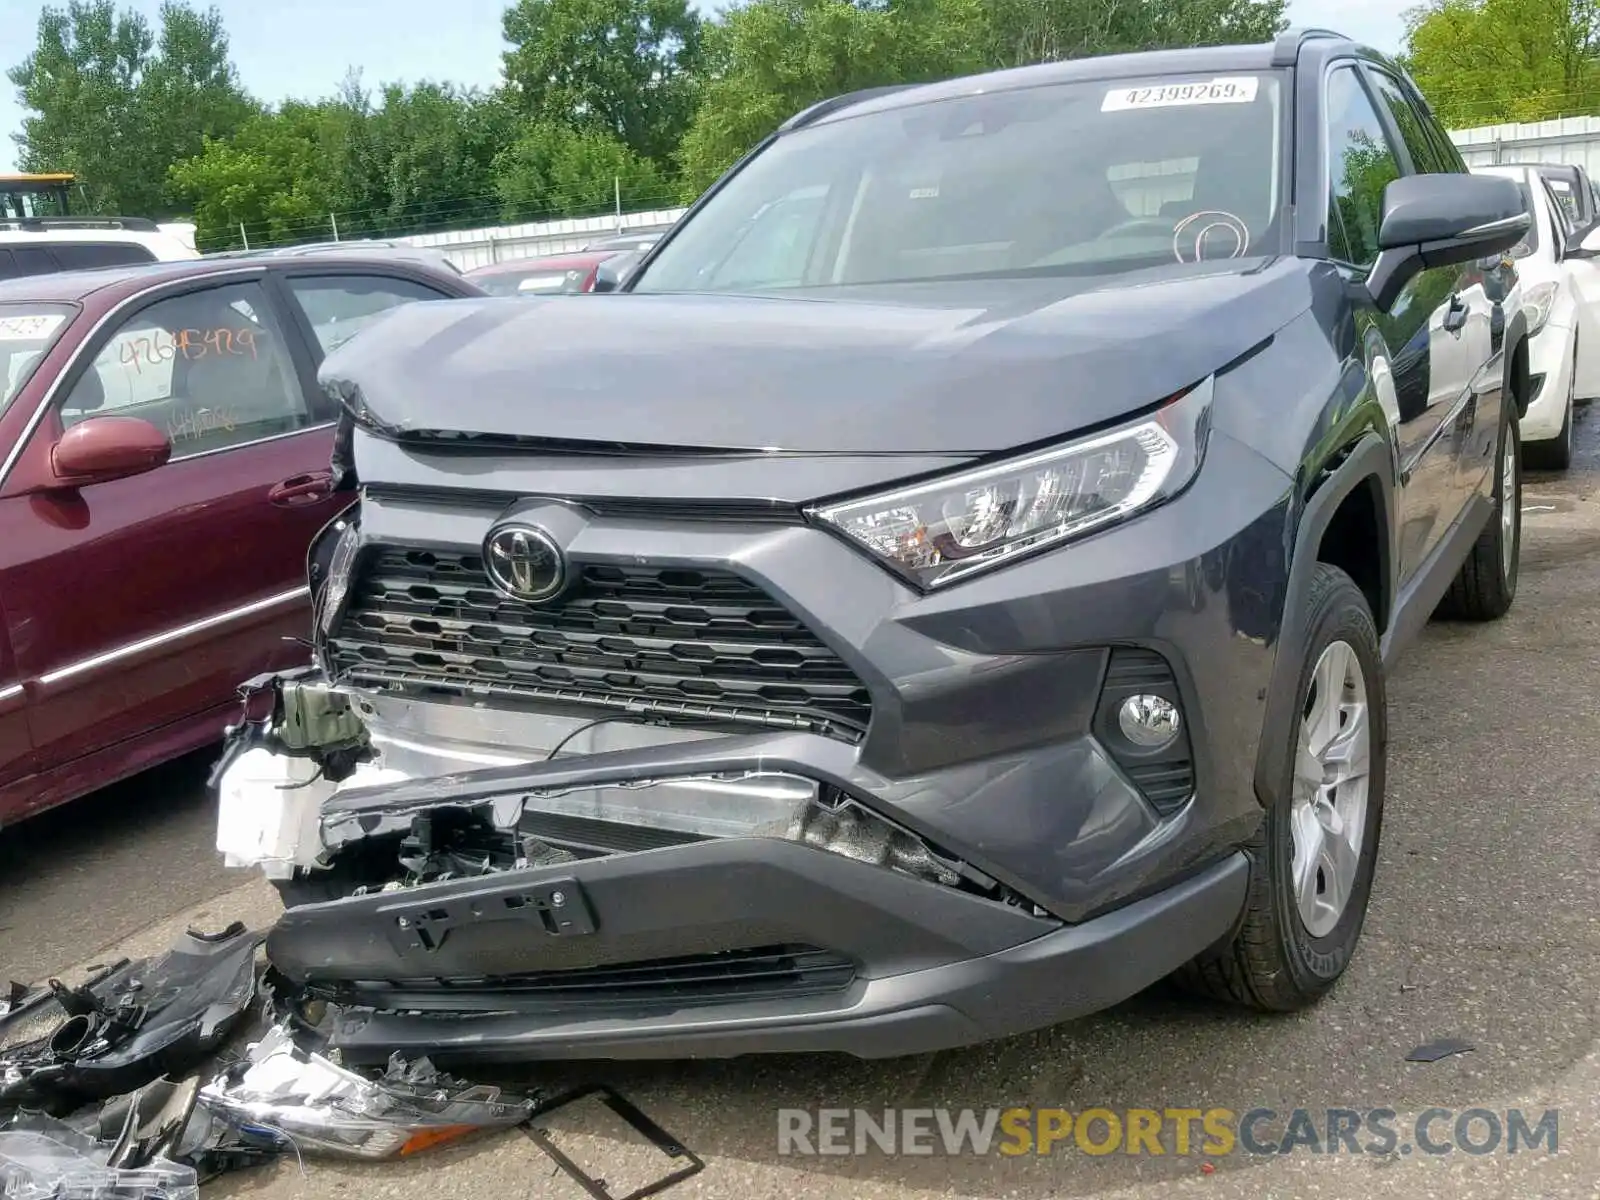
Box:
632 74 1283 291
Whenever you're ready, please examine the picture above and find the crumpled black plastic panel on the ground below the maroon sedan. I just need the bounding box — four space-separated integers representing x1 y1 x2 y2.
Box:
0 925 261 1115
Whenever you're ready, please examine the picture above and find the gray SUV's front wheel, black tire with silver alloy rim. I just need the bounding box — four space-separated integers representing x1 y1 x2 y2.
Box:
1176 563 1389 1013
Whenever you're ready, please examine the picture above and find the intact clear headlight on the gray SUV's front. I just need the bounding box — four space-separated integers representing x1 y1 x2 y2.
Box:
806 378 1211 590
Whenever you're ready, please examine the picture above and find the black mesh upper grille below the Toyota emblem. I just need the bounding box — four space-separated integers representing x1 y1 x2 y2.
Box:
328 547 872 741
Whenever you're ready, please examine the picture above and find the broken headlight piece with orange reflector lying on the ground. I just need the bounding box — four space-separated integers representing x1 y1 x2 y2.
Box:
200 1026 533 1158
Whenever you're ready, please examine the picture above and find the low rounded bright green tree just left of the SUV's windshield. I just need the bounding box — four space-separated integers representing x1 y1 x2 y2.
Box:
494 123 674 222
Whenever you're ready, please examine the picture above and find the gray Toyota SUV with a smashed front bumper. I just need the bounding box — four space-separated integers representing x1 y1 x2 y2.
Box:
218 30 1528 1062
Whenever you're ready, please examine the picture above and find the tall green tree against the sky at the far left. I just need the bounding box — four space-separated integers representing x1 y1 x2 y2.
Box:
6 0 256 216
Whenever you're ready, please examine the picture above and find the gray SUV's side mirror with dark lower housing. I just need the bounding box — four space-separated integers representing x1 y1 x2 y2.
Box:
1366 174 1533 310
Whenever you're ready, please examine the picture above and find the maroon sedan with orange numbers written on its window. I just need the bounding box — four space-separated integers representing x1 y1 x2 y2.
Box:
0 254 483 824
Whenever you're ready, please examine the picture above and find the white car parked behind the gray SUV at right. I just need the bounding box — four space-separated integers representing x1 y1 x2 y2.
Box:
1472 165 1600 470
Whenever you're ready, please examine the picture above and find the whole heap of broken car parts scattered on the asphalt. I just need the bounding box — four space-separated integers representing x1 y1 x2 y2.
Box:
0 915 706 1200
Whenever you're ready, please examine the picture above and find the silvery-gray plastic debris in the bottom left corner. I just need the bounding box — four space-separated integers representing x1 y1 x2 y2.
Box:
0 1114 200 1200
